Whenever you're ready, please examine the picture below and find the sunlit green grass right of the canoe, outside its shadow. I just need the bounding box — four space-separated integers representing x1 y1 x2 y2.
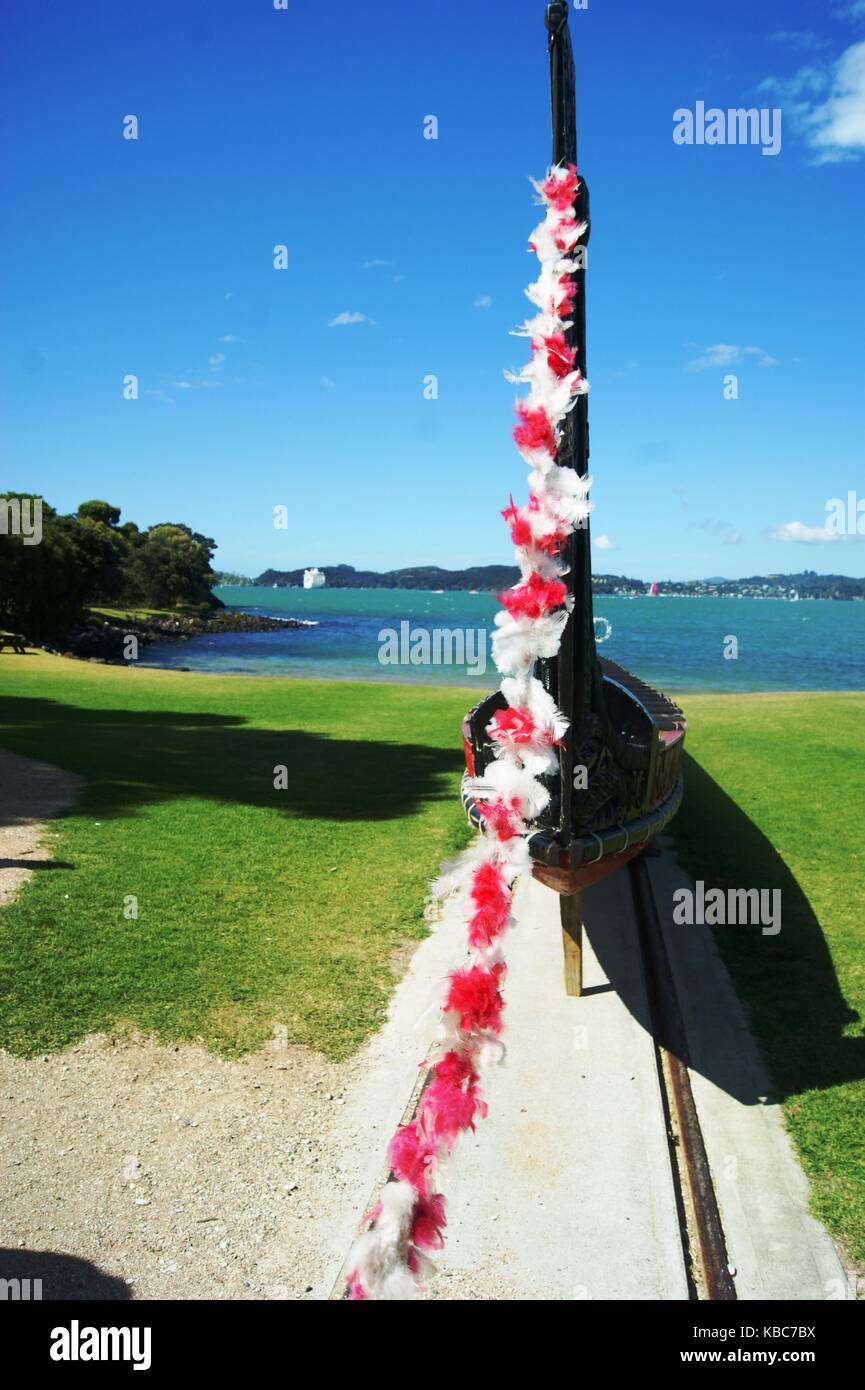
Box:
672 694 865 1259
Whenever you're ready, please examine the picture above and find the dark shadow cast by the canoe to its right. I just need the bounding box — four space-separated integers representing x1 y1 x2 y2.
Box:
585 755 865 1105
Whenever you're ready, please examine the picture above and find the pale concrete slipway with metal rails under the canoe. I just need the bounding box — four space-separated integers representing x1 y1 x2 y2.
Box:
313 851 851 1300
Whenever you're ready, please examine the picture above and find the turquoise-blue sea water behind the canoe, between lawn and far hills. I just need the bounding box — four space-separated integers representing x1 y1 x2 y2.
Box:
142 587 865 694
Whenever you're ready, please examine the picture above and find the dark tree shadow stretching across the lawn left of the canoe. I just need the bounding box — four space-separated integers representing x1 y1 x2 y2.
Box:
0 696 462 824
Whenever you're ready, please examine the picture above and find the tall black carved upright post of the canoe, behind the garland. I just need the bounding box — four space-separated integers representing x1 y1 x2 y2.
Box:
538 0 599 849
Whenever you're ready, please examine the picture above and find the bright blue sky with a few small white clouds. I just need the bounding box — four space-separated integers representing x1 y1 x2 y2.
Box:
0 0 865 578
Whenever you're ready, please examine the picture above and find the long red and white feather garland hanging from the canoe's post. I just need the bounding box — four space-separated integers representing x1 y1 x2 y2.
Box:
348 165 591 1301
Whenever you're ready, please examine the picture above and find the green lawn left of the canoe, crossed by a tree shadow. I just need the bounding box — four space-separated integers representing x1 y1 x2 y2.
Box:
0 653 471 1058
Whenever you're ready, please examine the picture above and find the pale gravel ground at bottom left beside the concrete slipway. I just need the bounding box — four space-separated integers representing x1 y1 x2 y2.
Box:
0 1037 362 1298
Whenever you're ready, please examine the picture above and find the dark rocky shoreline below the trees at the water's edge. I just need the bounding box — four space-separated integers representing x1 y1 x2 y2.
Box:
45 609 310 666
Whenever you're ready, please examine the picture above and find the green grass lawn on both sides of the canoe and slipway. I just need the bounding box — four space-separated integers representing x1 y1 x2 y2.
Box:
0 653 865 1259
